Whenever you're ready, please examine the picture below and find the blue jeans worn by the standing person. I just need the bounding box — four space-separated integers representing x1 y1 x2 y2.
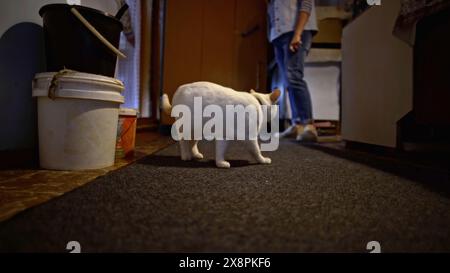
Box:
272 31 313 124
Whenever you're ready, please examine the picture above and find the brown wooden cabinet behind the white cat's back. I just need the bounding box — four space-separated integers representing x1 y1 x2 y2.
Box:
162 0 268 124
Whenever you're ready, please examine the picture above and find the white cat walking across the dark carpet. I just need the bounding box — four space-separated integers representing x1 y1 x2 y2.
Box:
161 82 280 168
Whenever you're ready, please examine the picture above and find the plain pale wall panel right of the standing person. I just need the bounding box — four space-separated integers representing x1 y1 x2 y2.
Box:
342 0 413 147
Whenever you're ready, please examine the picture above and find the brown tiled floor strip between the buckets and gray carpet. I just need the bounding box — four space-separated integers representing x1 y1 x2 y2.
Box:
0 132 172 221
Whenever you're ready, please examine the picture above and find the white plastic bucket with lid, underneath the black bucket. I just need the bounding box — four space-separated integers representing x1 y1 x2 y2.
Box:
33 72 124 170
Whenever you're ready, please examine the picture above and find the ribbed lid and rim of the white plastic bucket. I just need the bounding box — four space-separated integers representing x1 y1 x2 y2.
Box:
33 71 125 103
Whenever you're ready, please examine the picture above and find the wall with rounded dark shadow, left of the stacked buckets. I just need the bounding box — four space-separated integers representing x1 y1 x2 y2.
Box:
0 0 65 151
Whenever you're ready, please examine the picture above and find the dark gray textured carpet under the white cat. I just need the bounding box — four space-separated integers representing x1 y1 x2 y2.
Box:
0 141 450 252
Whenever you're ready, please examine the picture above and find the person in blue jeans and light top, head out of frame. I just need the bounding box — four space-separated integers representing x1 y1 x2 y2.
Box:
268 0 318 142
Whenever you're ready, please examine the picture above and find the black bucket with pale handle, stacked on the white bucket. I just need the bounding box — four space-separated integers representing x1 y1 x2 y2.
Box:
39 4 123 77
